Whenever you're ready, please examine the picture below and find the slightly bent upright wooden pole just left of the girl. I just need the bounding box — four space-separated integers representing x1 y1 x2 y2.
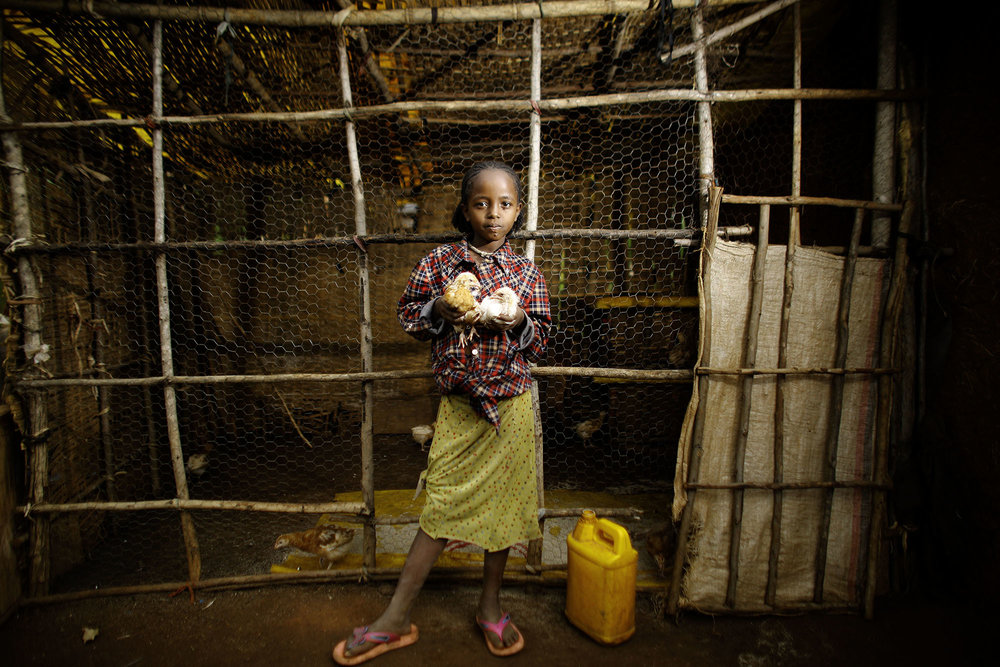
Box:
337 28 377 568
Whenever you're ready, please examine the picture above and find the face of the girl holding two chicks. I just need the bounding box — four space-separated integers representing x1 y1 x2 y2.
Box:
462 169 521 252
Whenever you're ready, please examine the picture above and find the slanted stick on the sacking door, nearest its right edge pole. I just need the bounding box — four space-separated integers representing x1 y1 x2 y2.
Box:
813 209 865 603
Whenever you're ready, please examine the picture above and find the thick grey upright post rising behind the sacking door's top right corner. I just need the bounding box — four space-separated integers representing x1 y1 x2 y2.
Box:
872 0 899 248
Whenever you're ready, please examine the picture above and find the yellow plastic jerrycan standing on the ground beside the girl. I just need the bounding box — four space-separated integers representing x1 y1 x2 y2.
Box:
566 510 639 644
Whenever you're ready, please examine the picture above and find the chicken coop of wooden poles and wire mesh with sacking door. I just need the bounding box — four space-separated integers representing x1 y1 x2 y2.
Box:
0 0 919 612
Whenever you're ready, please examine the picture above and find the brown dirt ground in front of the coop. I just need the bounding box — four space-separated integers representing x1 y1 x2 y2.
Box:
0 583 995 667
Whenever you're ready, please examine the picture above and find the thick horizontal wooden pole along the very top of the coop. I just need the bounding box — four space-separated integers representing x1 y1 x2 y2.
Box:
0 0 758 28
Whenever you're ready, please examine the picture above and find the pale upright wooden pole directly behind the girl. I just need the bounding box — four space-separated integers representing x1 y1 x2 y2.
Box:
524 19 545 568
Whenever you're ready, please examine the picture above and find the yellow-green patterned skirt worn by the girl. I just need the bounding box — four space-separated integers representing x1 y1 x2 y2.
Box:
420 392 542 551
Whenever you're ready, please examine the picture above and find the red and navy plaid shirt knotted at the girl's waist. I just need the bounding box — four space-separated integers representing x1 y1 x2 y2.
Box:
397 241 552 429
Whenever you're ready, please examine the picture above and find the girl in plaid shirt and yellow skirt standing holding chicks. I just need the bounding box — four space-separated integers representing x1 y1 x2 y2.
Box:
333 162 552 665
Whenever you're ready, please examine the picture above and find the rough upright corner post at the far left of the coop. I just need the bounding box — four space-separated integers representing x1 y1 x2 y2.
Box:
0 22 50 597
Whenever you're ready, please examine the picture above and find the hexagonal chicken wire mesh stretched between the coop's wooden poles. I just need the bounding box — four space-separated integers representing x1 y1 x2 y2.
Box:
3 2 884 589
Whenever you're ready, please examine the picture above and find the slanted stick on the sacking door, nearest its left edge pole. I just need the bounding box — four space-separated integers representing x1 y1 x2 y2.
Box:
726 204 771 609
